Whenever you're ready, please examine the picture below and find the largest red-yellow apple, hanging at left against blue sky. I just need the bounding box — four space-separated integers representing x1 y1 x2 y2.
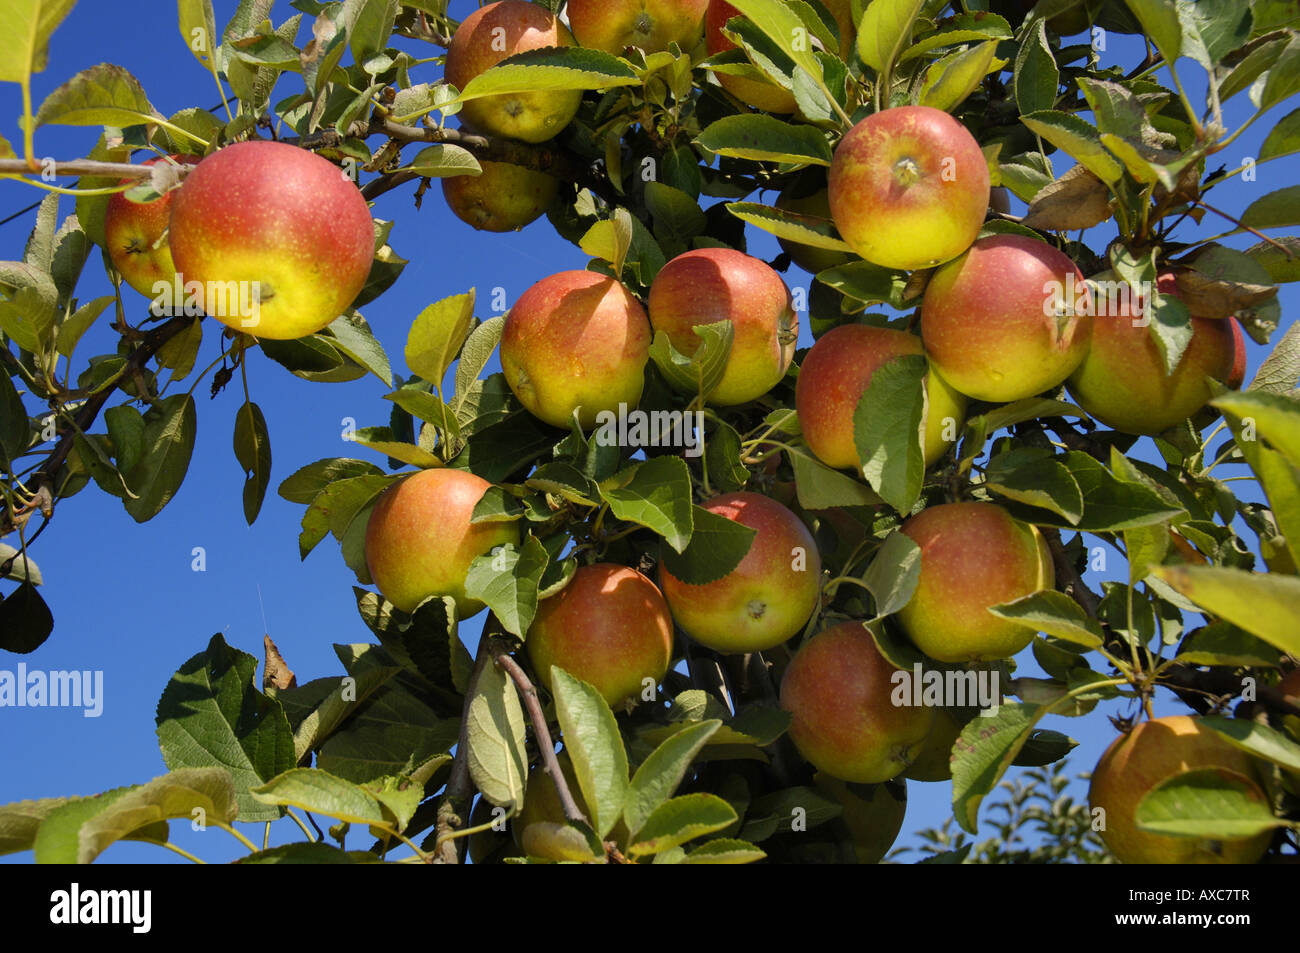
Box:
168 139 374 339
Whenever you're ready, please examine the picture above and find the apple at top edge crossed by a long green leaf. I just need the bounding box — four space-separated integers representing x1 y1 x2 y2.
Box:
445 0 582 142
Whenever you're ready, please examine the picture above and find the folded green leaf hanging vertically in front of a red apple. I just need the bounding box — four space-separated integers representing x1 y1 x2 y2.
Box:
853 355 926 514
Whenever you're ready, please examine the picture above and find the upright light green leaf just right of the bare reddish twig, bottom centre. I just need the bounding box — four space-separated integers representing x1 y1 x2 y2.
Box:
551 666 628 840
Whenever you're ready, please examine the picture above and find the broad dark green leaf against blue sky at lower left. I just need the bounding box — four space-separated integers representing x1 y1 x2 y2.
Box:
156 634 295 822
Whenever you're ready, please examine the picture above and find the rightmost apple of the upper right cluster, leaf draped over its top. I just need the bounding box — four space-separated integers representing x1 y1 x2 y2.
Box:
1067 274 1245 436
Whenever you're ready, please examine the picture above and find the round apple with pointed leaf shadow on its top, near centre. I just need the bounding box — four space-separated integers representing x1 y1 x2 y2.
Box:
501 272 650 429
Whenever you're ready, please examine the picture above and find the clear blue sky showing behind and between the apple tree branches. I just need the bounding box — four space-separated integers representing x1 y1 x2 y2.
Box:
0 0 1297 862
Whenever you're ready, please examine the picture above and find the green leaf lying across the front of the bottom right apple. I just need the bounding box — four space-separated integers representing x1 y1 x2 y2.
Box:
1135 770 1287 841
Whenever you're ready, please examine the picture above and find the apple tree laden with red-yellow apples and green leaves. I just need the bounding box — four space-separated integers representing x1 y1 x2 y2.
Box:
0 0 1300 863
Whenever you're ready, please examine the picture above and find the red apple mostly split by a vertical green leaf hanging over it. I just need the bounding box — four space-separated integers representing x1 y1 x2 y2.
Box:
794 324 966 469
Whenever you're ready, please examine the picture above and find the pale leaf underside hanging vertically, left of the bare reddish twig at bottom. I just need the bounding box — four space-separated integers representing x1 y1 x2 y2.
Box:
467 655 528 810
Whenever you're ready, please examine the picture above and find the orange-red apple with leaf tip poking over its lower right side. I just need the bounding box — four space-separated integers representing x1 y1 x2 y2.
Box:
897 503 1056 662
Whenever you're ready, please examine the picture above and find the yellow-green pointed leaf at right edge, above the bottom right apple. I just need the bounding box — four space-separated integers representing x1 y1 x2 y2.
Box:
1152 566 1300 655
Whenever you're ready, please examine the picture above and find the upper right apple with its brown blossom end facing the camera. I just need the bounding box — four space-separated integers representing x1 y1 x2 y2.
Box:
828 105 989 269
